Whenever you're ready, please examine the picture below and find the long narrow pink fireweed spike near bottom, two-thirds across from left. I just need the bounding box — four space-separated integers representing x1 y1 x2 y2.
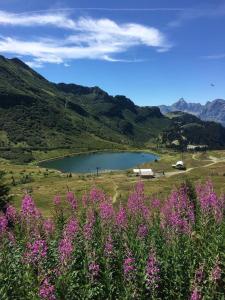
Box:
146 251 160 289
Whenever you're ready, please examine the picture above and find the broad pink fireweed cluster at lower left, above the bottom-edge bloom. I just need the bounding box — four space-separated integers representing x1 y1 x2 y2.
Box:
25 240 48 263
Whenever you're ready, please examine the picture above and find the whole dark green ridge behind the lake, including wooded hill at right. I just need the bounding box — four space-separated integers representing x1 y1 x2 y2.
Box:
0 56 225 161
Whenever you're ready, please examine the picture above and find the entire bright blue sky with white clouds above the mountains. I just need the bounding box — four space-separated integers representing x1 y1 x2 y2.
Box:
0 0 225 105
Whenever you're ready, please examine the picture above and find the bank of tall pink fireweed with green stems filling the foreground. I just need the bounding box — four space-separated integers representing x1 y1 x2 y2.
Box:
0 181 225 300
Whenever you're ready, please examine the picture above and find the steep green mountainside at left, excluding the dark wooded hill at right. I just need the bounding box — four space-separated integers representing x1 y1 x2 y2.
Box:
0 57 168 147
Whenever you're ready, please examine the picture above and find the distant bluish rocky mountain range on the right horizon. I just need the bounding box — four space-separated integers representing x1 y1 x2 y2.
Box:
159 98 225 127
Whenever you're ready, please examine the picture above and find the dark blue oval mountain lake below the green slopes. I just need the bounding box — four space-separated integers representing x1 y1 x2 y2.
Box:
40 152 158 173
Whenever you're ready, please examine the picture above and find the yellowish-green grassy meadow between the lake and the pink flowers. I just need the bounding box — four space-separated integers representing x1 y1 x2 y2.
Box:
0 150 225 216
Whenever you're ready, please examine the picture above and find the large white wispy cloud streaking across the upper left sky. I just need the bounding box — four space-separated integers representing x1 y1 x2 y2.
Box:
0 12 171 67
